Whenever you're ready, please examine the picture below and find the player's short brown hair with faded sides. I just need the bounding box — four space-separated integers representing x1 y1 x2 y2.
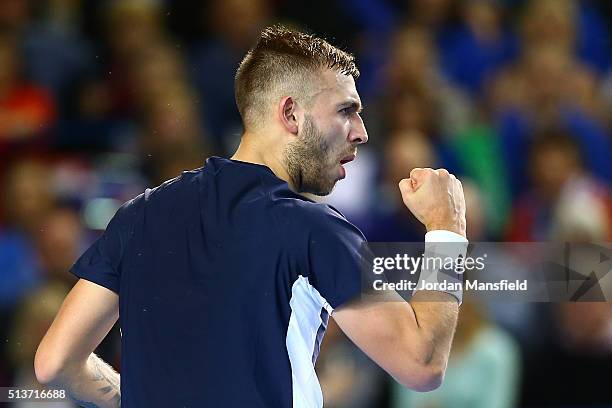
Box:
234 25 359 129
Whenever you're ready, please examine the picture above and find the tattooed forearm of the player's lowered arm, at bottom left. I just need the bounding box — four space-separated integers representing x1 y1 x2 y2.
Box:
51 353 121 408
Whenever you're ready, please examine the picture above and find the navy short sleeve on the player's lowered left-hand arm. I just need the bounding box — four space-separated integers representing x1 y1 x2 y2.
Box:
70 202 129 294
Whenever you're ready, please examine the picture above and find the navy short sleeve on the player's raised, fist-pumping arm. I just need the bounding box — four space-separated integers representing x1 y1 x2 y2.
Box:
306 206 367 309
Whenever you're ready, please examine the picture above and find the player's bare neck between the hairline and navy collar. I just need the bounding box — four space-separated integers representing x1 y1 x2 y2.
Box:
231 132 295 191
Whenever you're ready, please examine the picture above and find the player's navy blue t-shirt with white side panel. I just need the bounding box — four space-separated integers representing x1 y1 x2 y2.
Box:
71 157 365 408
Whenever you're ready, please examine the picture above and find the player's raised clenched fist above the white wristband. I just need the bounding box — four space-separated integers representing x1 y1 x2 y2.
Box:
399 168 465 237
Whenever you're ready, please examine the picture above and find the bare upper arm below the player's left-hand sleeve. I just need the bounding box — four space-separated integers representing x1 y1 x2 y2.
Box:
37 279 119 364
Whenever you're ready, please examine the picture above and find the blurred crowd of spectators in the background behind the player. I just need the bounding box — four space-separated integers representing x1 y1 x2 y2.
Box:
0 0 612 408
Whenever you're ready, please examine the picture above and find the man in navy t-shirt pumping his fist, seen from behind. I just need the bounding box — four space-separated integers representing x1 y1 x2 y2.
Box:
35 26 465 408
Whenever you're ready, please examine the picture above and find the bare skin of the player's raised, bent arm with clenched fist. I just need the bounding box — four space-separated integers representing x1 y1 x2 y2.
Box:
332 169 465 391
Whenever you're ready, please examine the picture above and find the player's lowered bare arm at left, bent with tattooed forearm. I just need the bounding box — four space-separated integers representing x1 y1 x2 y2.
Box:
34 279 121 408
